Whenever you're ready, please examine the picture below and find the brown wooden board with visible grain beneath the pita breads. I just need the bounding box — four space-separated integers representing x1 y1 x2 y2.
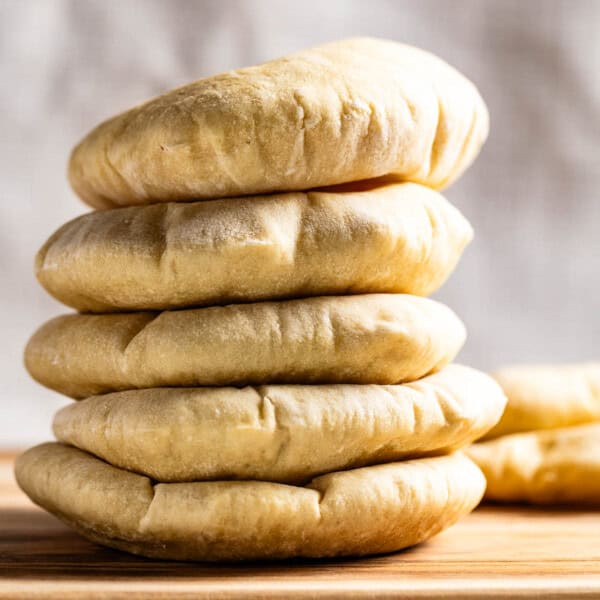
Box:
0 455 600 600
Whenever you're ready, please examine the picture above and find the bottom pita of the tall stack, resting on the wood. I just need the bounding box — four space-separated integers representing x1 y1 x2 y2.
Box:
16 444 485 561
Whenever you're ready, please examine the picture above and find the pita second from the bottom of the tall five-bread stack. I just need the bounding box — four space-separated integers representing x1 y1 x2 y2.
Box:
54 365 505 483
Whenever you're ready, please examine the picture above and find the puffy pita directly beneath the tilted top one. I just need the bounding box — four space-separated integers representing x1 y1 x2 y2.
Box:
36 183 472 312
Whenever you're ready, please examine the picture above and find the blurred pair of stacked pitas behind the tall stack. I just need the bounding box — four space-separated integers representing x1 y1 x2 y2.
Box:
469 363 600 506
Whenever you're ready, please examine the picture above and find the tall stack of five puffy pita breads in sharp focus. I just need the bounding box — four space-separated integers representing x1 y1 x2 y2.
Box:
16 39 505 560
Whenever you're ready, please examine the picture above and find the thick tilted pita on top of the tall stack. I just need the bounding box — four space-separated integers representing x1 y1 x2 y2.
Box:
69 39 488 208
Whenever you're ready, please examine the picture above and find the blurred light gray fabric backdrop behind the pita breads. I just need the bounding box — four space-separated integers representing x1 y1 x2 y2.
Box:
0 0 600 447
